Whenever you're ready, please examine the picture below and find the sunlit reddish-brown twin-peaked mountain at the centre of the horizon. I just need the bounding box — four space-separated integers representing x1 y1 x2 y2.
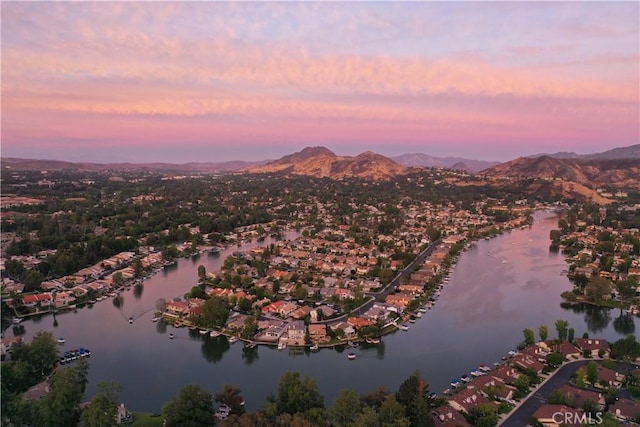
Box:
243 147 408 180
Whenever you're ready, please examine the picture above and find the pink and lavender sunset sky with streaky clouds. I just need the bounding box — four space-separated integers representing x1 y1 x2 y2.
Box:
0 1 640 163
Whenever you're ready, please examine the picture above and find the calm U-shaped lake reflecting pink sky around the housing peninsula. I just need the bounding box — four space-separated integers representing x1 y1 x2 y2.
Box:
8 212 640 412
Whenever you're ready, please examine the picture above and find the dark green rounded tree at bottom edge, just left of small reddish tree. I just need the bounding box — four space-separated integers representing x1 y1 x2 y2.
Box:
162 384 215 427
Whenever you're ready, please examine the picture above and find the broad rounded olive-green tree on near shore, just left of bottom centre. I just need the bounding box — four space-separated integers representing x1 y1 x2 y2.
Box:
274 372 324 415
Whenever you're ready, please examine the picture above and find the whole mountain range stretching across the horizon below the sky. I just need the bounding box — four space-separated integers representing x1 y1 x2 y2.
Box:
1 144 640 189
